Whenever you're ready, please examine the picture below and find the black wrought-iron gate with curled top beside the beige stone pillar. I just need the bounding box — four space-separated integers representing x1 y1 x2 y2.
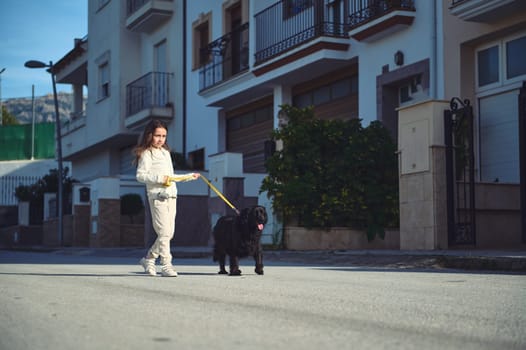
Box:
444 97 476 246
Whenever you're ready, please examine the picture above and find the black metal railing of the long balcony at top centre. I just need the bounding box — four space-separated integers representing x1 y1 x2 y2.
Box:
254 0 349 64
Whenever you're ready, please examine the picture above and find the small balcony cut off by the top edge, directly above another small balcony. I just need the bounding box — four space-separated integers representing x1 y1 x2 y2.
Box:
126 0 173 33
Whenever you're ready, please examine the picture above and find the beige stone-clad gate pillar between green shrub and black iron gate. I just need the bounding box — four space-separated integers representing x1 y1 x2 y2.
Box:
398 101 449 250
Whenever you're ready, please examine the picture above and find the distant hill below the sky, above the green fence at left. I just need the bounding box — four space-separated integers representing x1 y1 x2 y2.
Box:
3 92 77 124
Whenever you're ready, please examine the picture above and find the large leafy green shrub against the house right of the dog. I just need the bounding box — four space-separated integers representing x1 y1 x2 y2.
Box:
260 105 399 240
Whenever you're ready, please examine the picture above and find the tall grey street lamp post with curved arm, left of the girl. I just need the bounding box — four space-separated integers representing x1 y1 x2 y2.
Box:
24 60 64 245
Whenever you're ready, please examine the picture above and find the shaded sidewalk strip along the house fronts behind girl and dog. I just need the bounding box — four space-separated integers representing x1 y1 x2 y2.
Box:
5 246 526 273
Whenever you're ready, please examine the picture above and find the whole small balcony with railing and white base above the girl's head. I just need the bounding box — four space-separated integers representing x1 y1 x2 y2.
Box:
124 72 173 128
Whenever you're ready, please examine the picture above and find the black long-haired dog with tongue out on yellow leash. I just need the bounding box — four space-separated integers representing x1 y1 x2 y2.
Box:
214 206 267 276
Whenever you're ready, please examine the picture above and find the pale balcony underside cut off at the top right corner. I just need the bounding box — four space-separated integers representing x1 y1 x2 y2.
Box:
449 0 526 23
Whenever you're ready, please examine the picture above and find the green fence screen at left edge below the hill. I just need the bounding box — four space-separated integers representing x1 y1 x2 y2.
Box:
0 123 55 161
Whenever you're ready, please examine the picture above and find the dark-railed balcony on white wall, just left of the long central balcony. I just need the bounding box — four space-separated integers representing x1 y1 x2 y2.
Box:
199 22 248 92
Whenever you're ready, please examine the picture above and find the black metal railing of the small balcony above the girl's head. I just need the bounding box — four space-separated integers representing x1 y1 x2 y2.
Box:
126 72 172 117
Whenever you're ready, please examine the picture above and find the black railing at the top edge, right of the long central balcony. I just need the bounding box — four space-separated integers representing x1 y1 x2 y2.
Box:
348 0 415 30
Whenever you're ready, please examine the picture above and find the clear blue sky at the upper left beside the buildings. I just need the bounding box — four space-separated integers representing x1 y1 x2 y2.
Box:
0 0 88 100
